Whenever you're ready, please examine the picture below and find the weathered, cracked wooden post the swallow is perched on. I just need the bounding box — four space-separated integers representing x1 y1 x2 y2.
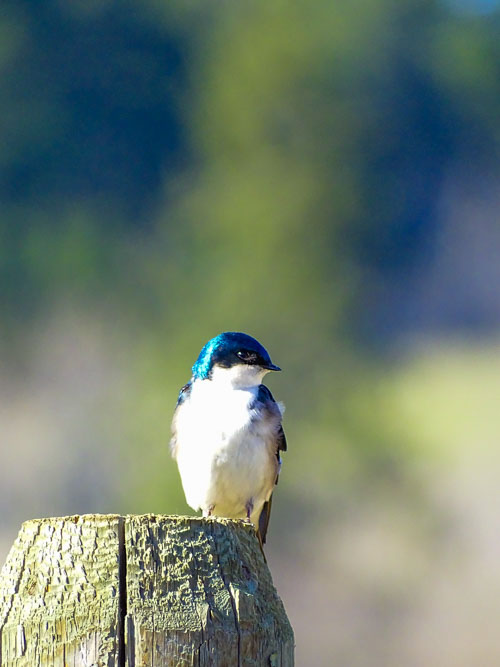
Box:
0 515 294 667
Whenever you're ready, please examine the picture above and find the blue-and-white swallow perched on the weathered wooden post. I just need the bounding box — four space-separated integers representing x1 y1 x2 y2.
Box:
170 331 287 547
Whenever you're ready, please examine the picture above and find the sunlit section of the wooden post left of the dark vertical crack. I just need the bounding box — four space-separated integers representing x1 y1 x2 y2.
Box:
0 515 122 667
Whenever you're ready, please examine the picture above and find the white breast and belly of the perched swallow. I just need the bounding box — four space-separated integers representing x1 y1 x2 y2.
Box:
176 381 277 523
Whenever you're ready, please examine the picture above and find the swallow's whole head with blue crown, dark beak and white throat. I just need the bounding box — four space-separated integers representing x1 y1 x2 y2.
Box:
193 331 281 386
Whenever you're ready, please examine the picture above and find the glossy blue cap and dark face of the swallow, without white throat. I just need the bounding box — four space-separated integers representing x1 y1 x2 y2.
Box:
193 331 281 380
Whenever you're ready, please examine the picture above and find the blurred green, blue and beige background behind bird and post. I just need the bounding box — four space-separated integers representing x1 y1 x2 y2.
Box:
0 0 500 667
